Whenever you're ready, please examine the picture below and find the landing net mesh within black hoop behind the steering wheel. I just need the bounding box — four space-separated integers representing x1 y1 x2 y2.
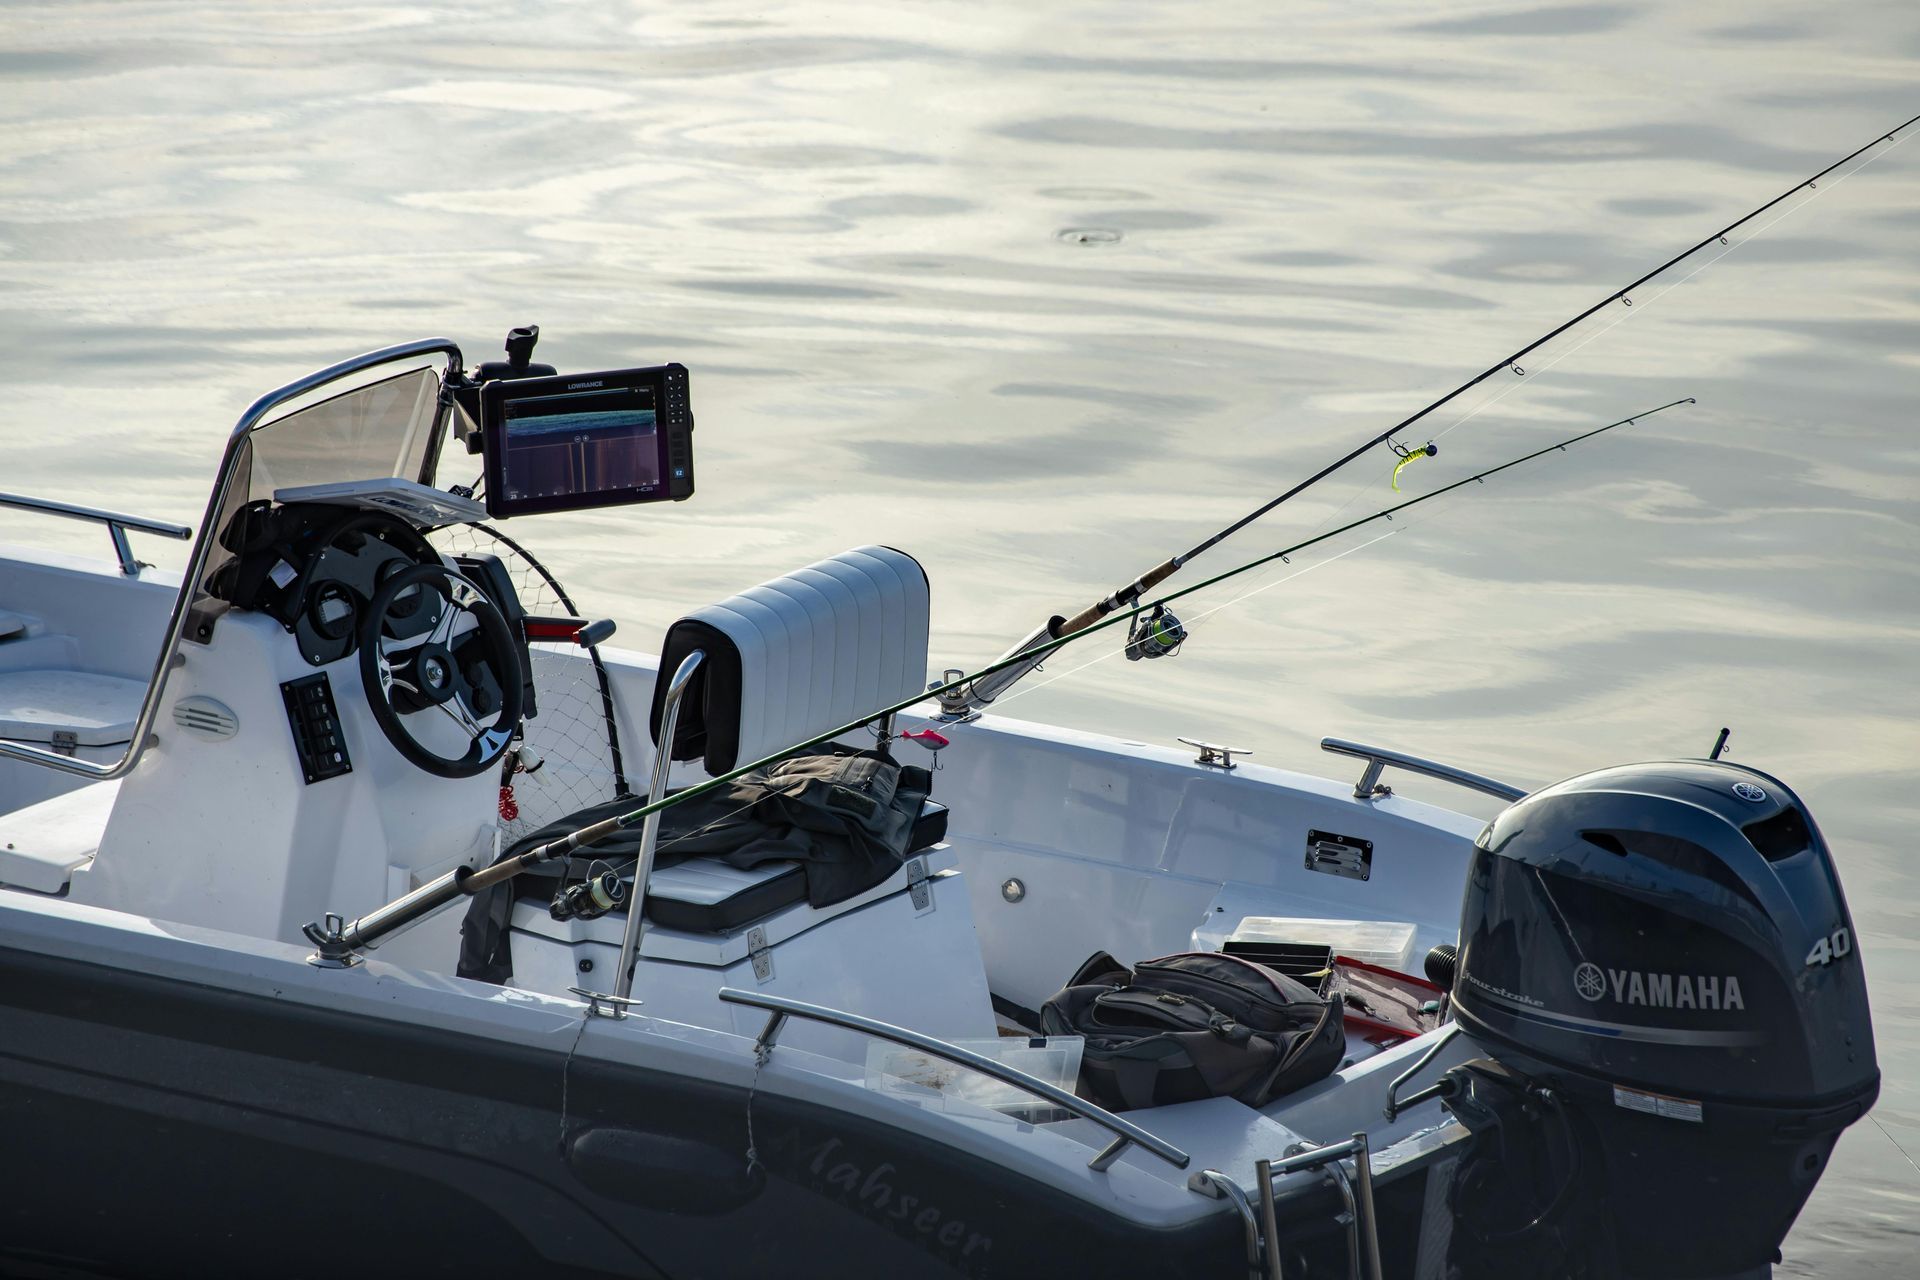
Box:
432 524 628 848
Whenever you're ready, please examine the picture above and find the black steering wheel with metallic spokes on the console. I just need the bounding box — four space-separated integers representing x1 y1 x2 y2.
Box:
359 564 524 777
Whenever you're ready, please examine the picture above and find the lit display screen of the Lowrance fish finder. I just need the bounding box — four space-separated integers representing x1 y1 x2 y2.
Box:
501 386 660 503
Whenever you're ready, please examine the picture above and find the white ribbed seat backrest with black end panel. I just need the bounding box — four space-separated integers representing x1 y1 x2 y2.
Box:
651 547 929 773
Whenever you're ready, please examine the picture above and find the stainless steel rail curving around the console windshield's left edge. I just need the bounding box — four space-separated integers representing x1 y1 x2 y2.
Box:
0 338 461 781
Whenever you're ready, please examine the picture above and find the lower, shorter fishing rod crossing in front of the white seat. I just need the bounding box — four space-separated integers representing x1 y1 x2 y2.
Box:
453 397 1695 901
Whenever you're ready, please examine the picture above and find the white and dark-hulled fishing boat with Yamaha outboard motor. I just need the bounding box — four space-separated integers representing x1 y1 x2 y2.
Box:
0 119 1891 1280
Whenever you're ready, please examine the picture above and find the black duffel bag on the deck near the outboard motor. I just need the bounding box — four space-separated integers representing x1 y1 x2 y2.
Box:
1041 952 1346 1111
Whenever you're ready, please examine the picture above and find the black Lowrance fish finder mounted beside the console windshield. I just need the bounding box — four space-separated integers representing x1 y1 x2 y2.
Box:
480 365 693 518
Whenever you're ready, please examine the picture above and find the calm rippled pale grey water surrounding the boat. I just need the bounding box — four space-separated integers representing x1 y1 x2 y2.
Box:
0 0 1920 1276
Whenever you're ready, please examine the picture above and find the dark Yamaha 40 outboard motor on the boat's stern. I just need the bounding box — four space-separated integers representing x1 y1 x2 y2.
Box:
1448 760 1880 1278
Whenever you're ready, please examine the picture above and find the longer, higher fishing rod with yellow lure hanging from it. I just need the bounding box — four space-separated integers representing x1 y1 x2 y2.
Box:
941 115 1920 718
